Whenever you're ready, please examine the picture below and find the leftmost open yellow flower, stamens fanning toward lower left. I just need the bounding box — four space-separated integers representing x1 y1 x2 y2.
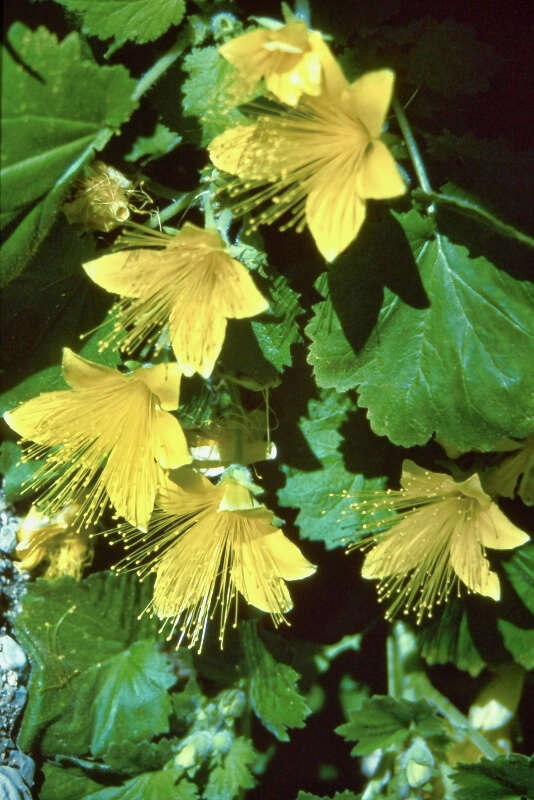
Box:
4 348 191 528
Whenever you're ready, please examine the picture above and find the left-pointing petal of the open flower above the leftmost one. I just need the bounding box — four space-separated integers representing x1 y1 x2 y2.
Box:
82 250 146 297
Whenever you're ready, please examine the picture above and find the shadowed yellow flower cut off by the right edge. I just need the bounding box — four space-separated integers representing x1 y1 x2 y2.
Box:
484 434 534 506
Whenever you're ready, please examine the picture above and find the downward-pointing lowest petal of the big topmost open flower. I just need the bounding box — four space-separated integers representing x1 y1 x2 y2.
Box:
306 168 365 262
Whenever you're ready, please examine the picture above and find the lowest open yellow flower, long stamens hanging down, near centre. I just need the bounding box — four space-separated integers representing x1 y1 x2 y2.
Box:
111 468 315 649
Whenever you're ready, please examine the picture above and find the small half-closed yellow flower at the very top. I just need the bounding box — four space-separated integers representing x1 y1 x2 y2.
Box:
219 20 322 106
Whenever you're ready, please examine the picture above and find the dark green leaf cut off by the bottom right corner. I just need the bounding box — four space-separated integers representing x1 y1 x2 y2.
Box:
452 753 534 800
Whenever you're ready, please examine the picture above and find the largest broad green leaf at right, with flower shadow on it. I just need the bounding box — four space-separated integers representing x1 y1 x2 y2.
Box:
307 211 534 450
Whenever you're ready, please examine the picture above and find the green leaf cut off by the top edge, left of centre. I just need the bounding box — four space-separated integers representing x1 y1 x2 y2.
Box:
35 0 185 44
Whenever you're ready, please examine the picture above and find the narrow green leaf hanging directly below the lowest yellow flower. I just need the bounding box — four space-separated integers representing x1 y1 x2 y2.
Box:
240 622 311 742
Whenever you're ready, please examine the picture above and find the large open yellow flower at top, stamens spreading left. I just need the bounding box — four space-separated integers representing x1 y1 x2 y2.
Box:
209 40 405 261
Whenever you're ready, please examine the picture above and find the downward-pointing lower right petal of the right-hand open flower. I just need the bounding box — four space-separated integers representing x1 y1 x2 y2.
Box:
450 523 501 600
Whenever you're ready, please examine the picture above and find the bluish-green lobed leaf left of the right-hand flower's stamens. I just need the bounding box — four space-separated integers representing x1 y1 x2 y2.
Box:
278 391 385 550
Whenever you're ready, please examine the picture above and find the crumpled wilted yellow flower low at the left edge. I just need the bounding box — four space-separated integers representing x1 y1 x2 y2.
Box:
15 503 93 580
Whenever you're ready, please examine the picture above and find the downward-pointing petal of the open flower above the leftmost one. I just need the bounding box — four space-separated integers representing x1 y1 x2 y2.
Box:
169 304 226 378
